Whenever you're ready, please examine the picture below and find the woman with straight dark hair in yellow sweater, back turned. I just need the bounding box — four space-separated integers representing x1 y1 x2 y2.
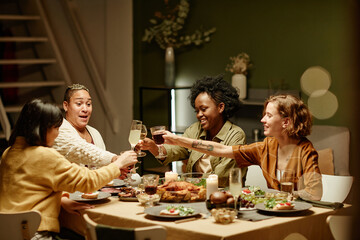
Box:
0 99 137 239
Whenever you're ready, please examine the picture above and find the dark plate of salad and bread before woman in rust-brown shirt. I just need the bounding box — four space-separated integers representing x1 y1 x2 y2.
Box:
255 198 312 213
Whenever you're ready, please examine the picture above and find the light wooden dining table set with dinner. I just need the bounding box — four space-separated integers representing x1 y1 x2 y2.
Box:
60 196 352 240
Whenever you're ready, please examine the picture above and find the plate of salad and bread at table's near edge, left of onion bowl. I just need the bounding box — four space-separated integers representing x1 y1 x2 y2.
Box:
144 205 200 218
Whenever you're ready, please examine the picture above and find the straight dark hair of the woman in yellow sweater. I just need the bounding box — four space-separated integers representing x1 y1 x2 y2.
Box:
9 99 63 146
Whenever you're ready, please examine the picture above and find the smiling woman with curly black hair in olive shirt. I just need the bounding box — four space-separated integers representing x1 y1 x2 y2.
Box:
139 76 246 187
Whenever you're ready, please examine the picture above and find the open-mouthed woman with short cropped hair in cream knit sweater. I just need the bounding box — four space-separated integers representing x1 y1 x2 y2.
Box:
53 84 121 167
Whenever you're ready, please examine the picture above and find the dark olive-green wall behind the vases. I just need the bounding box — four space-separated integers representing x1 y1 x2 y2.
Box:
134 0 356 171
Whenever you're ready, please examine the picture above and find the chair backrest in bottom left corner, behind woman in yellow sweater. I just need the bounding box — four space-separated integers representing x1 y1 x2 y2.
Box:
0 210 41 240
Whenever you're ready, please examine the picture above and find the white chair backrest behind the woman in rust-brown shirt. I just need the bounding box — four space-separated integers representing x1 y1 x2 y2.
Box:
321 174 354 203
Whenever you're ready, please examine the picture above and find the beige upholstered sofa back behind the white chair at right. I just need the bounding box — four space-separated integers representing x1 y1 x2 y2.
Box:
307 125 350 176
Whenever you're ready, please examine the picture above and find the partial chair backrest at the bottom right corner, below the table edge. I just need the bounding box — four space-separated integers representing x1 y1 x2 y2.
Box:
326 215 352 240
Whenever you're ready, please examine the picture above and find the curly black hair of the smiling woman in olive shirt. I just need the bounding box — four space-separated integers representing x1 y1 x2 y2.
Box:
189 75 241 121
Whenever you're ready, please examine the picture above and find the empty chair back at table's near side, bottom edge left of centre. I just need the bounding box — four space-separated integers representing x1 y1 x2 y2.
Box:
83 213 167 240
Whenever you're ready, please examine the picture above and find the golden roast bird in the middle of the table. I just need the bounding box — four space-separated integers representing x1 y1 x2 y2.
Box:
156 181 206 202
